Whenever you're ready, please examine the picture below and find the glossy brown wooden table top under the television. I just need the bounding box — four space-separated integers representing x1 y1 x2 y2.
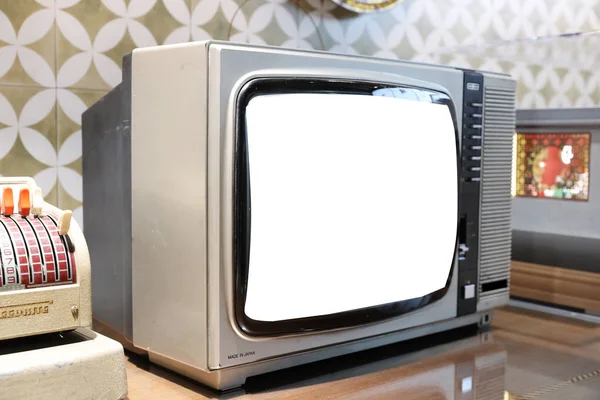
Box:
127 308 600 400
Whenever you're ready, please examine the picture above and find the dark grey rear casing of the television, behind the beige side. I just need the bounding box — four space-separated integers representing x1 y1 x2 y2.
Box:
82 52 133 341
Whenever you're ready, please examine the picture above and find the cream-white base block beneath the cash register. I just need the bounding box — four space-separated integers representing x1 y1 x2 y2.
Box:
0 329 127 400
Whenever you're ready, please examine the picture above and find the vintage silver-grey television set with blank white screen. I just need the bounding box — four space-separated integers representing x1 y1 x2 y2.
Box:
83 41 515 389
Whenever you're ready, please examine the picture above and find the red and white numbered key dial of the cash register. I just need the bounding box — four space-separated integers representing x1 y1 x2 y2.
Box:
0 186 77 290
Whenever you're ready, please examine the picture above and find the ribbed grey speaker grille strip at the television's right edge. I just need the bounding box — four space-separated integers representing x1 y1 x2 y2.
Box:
477 74 515 311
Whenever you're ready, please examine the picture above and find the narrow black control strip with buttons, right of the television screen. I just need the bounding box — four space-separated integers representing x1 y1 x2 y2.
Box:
457 71 483 316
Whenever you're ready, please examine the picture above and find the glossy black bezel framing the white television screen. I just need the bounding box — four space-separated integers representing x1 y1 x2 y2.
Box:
232 77 461 336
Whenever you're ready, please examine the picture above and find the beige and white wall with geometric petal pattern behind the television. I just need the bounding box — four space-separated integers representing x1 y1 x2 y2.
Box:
0 0 600 223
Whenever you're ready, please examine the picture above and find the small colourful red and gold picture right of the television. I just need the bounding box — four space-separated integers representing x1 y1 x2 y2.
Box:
513 132 591 201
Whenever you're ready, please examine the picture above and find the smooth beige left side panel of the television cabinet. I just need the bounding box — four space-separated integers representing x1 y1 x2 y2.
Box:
131 43 208 369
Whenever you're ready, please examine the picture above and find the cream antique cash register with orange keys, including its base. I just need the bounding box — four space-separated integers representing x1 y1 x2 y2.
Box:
0 177 127 399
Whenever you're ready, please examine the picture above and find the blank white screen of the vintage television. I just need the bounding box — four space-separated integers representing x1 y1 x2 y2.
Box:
244 93 458 322
